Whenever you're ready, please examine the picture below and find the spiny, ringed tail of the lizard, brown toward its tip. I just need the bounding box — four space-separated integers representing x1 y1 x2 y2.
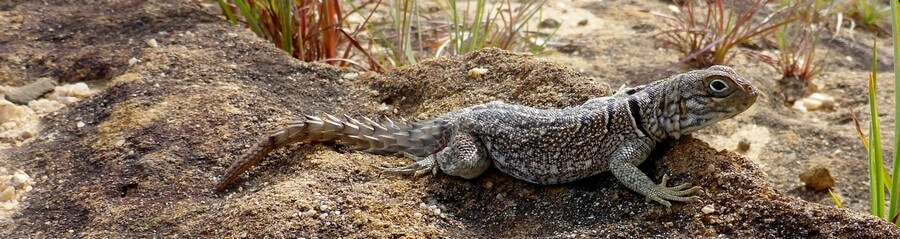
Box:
216 114 449 191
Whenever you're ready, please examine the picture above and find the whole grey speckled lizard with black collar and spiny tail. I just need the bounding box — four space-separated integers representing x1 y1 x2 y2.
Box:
216 66 758 207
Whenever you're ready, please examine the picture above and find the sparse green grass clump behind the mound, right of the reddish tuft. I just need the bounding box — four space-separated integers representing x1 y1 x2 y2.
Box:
346 0 557 67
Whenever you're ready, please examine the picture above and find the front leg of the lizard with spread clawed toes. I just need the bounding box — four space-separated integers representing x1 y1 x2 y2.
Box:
609 140 700 207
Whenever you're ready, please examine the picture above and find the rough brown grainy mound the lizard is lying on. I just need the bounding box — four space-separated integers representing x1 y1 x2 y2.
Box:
0 1 900 238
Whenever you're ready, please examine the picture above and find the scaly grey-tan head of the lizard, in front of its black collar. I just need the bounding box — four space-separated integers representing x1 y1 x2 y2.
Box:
665 66 759 138
